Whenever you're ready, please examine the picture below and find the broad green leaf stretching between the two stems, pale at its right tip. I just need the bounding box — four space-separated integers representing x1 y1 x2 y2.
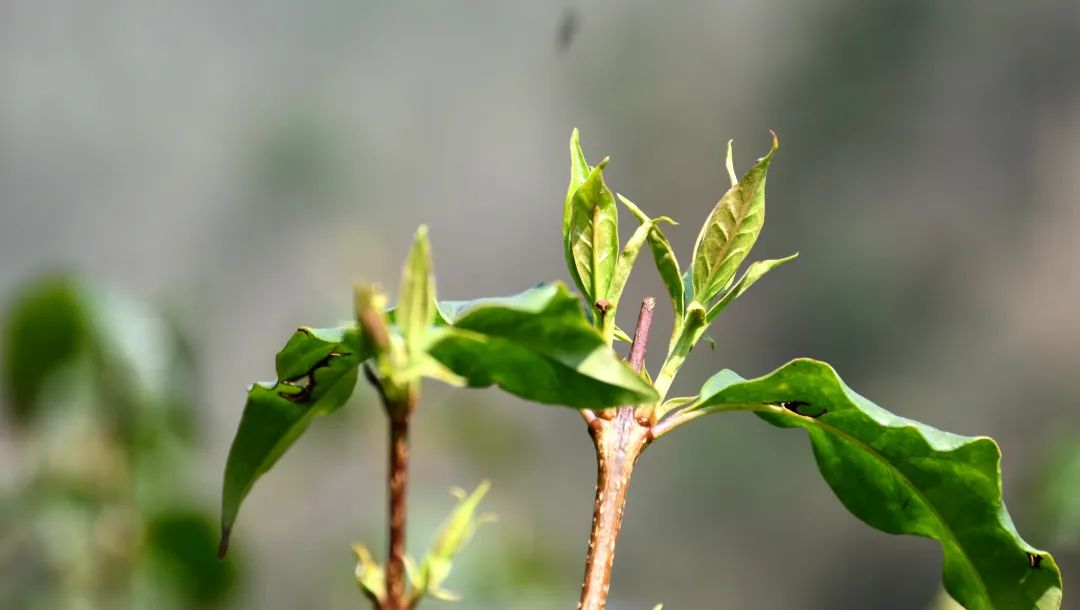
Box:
430 283 657 408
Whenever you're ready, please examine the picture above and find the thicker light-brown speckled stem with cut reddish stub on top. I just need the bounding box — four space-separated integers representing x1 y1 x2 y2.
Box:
578 298 657 610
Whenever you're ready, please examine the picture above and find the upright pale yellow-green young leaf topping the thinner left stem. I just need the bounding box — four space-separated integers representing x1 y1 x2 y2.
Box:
396 226 435 357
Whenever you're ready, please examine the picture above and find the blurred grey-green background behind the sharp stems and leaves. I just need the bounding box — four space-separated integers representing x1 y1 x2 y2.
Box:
0 0 1080 610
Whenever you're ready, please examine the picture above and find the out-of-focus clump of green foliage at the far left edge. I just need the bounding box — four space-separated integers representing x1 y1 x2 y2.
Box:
0 275 235 610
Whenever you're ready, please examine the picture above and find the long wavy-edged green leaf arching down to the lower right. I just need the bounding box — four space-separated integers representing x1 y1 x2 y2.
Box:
690 360 1062 610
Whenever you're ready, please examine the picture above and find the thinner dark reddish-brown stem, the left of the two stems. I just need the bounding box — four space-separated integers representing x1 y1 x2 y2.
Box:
386 414 409 610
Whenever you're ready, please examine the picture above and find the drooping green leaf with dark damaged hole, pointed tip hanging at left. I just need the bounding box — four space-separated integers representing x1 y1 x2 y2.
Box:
219 324 372 554
